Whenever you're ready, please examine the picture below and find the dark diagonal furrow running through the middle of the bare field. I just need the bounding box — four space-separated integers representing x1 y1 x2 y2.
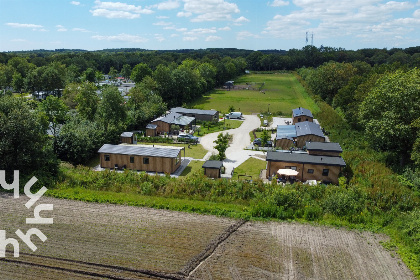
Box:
179 219 248 277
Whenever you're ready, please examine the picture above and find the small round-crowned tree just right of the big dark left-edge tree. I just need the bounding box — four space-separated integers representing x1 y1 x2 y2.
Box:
38 95 69 136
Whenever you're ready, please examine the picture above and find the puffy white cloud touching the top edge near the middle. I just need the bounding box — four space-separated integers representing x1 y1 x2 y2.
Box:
178 0 240 22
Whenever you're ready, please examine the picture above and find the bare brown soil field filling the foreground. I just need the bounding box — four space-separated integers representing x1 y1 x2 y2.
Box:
0 195 415 279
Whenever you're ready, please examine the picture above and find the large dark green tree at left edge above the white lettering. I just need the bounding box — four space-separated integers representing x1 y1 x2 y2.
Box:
0 96 58 179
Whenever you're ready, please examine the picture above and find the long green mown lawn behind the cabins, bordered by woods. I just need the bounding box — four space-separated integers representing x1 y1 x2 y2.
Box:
190 73 319 116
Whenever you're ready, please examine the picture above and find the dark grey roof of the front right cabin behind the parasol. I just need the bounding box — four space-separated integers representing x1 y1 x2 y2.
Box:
267 151 346 166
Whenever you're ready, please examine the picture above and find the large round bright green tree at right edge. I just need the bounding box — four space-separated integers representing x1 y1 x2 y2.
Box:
359 69 420 164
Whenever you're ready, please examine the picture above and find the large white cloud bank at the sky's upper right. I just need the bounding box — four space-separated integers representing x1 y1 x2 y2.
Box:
262 0 417 39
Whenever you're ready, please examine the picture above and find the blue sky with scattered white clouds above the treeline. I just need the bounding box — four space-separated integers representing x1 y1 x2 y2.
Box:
0 0 420 51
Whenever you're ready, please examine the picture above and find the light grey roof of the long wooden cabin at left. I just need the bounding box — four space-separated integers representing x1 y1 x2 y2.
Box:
98 144 181 158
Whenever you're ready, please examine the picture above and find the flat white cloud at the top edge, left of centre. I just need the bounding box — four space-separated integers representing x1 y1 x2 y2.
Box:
90 0 153 19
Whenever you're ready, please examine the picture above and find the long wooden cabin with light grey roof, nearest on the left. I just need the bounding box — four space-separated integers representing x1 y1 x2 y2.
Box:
98 144 183 174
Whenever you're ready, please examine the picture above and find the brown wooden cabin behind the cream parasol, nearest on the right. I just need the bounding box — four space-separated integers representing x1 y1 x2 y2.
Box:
266 151 346 184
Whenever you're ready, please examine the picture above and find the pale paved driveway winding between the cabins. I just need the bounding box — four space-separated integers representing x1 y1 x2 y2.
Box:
200 115 263 177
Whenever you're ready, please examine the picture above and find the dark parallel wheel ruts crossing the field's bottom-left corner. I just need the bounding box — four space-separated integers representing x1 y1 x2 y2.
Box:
0 250 185 280
